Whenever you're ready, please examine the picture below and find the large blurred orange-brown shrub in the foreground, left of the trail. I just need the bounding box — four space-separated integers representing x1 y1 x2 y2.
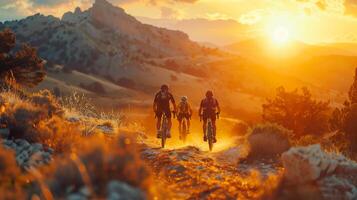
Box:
45 135 152 198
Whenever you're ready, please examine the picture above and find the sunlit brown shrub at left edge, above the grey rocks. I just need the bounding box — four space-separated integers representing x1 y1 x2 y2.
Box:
0 90 81 152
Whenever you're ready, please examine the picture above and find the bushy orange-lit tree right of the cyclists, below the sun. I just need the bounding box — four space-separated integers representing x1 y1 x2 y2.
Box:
263 87 329 137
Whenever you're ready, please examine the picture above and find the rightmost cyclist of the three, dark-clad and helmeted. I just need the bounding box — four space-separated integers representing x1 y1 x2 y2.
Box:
198 90 221 143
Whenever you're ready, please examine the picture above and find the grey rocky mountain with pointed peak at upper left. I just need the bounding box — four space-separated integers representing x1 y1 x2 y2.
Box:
0 0 202 71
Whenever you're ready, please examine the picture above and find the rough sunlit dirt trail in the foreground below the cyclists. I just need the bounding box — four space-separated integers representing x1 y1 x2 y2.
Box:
141 135 281 199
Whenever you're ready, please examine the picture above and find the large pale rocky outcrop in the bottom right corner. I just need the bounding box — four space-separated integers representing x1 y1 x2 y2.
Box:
282 145 357 199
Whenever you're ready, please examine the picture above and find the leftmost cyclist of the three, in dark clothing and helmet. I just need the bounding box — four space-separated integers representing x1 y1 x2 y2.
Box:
153 85 176 138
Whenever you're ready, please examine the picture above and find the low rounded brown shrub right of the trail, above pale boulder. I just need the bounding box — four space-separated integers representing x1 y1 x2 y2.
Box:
247 123 291 159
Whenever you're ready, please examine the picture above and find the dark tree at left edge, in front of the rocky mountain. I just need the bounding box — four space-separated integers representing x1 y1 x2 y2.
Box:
0 29 46 87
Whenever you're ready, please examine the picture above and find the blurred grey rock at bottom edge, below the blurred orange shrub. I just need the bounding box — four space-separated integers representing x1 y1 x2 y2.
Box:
107 181 145 200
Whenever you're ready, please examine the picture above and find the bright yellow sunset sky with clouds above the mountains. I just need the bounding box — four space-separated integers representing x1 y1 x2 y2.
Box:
0 0 357 43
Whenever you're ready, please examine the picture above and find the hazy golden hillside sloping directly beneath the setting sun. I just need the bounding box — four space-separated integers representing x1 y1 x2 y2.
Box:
224 38 357 92
